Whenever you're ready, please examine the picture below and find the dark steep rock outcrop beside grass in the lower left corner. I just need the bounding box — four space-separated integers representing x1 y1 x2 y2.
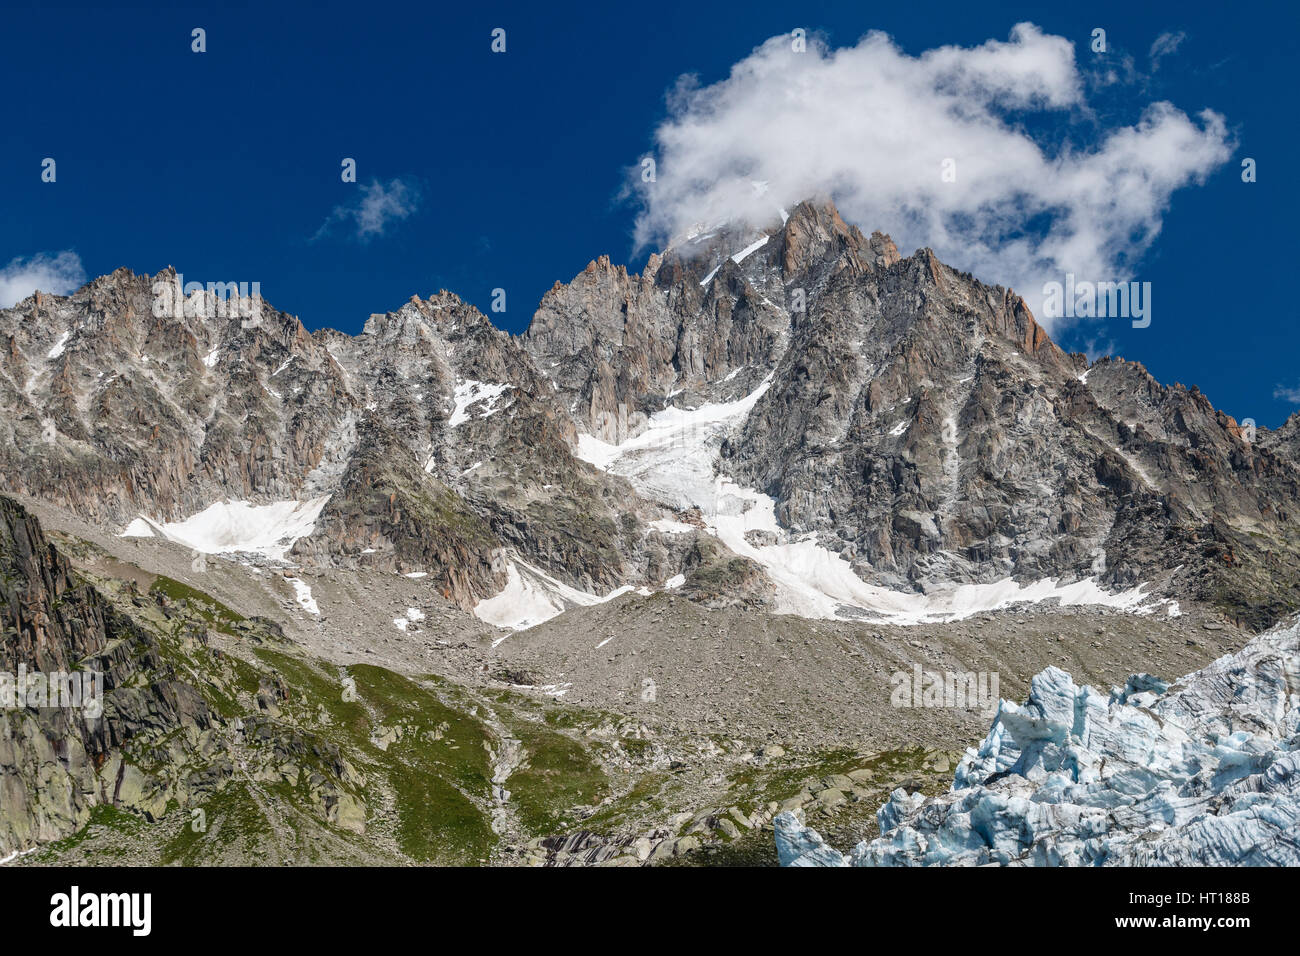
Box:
0 497 212 853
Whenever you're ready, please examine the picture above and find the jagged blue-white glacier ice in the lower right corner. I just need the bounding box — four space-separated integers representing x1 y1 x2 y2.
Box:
775 623 1300 866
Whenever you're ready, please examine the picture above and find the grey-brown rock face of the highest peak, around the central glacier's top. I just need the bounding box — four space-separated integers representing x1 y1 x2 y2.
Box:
525 203 1300 627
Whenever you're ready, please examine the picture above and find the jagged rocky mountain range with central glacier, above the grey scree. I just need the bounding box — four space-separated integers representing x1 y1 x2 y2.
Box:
0 202 1300 628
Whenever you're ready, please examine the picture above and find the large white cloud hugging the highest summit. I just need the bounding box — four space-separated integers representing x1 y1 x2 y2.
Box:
631 23 1230 329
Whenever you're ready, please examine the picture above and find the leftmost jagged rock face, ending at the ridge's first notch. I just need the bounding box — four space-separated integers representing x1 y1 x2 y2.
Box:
0 269 358 524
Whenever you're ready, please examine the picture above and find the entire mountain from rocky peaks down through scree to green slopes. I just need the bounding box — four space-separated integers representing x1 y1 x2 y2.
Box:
0 202 1300 866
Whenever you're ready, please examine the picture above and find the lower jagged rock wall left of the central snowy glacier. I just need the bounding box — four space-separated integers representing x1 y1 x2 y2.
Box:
0 269 672 605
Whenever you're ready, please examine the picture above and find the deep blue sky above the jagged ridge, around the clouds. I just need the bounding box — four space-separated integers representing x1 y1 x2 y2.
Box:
0 0 1300 425
